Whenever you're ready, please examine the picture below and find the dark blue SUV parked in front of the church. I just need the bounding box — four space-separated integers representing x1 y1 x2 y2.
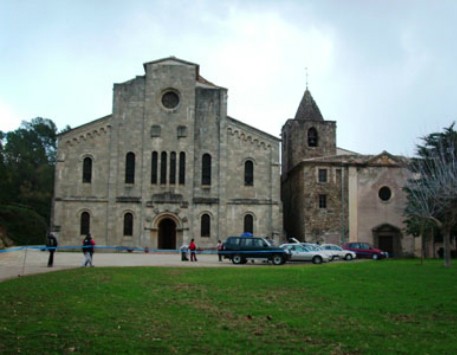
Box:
221 237 290 265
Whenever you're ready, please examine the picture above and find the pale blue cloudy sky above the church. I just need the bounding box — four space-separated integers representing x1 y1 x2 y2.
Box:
0 0 457 155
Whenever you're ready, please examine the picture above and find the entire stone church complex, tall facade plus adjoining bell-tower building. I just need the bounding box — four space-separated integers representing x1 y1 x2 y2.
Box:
51 57 415 256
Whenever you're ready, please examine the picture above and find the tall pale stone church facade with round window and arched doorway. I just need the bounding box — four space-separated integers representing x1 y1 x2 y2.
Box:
51 57 283 249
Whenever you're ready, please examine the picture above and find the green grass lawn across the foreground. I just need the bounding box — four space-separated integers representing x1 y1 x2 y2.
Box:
0 260 457 354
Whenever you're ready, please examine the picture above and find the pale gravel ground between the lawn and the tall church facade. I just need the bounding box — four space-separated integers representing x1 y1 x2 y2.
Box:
0 249 242 281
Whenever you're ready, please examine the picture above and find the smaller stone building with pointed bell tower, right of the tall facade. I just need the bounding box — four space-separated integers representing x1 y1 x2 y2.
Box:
282 89 416 256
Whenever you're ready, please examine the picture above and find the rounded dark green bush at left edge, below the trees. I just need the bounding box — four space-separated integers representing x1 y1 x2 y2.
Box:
0 205 48 245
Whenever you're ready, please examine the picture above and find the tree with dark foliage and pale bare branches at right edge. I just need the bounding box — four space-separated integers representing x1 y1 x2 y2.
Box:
405 123 457 267
